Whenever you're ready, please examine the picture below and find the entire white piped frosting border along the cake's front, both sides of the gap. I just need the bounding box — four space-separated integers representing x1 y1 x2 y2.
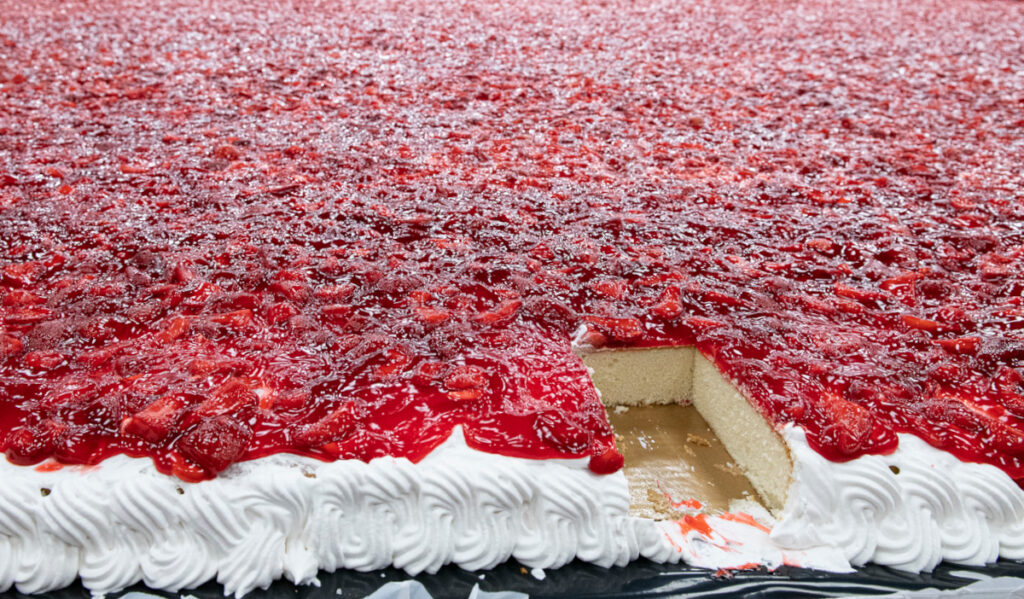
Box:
0 426 1024 595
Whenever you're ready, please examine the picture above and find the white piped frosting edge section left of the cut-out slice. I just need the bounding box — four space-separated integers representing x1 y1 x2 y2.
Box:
0 429 678 595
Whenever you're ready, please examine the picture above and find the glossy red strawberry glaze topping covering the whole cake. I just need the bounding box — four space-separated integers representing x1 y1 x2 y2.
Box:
0 0 1024 480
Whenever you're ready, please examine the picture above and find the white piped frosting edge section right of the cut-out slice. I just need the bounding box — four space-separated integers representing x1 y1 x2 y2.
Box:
771 425 1024 572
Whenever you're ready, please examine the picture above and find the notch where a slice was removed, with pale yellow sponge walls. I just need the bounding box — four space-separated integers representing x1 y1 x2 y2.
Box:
583 347 793 517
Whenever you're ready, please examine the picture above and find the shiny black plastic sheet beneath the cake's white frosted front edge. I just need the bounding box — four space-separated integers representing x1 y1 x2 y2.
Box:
0 560 1024 599
